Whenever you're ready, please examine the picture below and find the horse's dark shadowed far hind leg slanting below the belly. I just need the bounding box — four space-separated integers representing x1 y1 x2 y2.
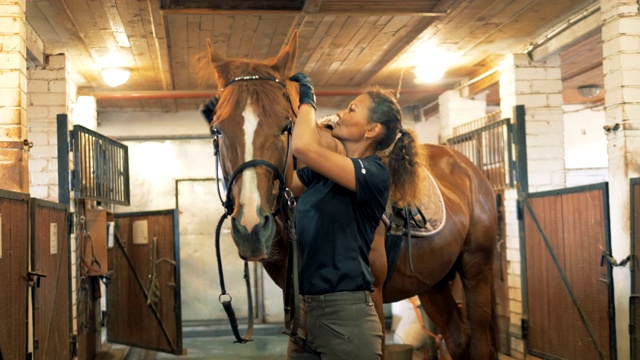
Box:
418 280 470 359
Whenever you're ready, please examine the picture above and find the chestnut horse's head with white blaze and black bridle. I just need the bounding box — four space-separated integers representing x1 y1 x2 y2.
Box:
209 32 298 260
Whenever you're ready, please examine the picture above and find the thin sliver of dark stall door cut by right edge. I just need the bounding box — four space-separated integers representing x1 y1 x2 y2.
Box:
629 178 640 360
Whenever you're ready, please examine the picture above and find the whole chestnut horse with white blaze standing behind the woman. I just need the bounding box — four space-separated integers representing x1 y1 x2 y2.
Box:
208 31 498 360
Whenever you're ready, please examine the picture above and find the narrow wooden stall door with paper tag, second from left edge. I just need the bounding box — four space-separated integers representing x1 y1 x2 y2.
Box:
30 199 71 360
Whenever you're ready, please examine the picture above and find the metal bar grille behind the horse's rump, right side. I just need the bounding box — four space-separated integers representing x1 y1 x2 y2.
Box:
447 111 514 190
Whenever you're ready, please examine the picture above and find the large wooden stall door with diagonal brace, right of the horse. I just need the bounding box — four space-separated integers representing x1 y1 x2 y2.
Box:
524 183 616 360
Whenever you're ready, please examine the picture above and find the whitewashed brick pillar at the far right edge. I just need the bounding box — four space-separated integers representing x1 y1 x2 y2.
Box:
600 0 640 359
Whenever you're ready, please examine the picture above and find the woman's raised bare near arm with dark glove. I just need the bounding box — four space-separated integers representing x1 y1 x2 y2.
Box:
291 73 356 191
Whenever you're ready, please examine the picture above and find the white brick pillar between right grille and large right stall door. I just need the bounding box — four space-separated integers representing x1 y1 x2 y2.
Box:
500 54 565 359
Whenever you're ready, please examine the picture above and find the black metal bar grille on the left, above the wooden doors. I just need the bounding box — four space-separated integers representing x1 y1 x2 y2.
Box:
73 125 130 205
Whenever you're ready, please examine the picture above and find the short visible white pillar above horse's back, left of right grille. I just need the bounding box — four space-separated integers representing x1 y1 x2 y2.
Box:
438 90 487 143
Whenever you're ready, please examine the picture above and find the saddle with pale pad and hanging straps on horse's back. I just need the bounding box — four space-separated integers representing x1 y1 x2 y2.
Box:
382 173 447 286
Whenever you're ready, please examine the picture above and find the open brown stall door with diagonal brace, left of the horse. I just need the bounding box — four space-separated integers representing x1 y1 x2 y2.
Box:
106 210 183 354
